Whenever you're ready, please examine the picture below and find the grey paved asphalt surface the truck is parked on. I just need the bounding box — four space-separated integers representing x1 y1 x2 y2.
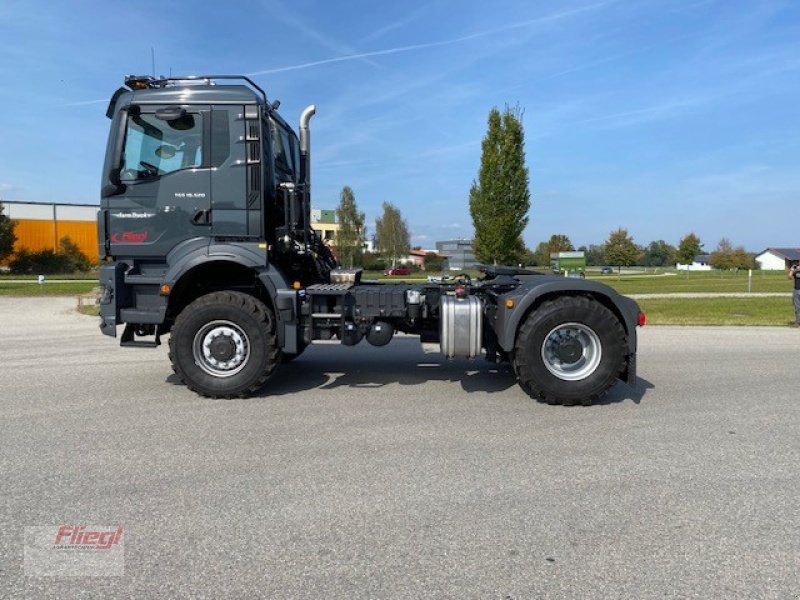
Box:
0 298 800 599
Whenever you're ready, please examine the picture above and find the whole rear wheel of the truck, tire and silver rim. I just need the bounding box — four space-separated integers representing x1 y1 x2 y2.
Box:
514 296 627 405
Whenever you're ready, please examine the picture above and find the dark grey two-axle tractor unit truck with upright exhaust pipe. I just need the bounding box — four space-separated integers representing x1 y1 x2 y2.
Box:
98 75 644 404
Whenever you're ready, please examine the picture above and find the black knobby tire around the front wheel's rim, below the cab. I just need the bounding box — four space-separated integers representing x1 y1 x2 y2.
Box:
169 291 280 398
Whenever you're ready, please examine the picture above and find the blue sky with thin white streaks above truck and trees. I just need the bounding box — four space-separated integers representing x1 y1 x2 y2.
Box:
0 0 800 251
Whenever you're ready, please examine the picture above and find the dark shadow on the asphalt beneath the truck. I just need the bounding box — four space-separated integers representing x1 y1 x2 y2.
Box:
167 337 654 404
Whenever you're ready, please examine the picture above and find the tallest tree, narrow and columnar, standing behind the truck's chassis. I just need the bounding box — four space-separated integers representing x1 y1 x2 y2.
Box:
469 107 531 264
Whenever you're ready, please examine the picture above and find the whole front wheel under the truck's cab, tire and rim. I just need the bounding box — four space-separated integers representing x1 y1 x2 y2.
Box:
169 292 280 398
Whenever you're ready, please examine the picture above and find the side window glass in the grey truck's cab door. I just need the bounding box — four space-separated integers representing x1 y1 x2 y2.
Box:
120 113 203 182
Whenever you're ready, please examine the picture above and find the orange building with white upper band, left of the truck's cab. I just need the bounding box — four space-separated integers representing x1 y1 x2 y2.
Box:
0 200 98 262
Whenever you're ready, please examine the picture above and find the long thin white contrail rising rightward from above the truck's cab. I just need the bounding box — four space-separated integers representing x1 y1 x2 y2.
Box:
248 0 618 77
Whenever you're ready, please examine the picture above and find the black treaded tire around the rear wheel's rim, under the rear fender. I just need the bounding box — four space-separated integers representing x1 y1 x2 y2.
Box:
513 296 627 406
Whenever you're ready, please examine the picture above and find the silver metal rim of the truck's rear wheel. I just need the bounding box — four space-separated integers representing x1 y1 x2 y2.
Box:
542 323 603 381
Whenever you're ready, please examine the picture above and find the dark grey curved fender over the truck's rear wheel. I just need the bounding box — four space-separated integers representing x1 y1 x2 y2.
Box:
493 276 639 355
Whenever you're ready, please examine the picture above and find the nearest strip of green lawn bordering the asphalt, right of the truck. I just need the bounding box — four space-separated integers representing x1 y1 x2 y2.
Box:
638 298 800 326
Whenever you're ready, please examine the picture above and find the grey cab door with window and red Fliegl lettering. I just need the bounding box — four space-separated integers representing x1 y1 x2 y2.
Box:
107 105 212 258
